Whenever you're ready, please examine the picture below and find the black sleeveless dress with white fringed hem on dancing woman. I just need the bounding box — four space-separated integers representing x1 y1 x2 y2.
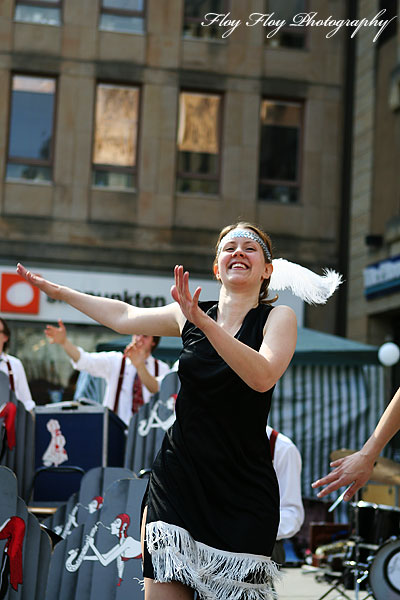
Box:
145 302 279 600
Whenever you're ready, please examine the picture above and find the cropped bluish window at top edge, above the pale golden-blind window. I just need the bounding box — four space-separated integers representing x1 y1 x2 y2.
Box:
100 0 145 33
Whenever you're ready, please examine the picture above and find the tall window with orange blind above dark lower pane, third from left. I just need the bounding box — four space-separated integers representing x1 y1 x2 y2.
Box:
177 92 221 194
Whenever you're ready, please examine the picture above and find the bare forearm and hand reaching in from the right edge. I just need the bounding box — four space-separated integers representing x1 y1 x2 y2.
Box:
312 388 400 500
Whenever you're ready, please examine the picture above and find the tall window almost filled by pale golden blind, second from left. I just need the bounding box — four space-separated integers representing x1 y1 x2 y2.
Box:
93 83 139 188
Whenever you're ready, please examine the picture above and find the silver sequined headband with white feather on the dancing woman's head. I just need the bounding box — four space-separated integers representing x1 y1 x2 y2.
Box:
217 229 343 304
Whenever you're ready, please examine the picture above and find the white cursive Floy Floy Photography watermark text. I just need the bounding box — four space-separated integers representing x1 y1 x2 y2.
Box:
201 8 397 42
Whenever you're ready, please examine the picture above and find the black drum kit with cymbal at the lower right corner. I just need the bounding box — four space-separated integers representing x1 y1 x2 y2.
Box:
319 450 400 600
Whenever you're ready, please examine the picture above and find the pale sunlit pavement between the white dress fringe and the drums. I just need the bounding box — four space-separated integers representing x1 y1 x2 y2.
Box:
276 568 360 600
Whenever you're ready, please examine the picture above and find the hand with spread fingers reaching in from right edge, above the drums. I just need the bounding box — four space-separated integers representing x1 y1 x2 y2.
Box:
312 451 375 500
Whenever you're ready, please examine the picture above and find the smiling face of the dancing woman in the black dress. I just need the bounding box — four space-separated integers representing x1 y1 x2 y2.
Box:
214 227 272 290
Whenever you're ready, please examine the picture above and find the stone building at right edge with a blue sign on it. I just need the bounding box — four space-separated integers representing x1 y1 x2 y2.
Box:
347 0 400 358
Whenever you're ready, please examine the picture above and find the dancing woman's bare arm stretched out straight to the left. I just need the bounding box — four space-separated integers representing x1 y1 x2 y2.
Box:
17 264 185 336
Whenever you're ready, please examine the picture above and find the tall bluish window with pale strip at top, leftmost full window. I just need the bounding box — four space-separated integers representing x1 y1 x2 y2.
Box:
7 75 56 181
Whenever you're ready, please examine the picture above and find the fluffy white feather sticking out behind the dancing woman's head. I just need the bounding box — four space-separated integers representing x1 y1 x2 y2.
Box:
269 258 343 304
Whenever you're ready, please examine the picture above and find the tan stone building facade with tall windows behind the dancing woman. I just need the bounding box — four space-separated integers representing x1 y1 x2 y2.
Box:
0 0 346 390
